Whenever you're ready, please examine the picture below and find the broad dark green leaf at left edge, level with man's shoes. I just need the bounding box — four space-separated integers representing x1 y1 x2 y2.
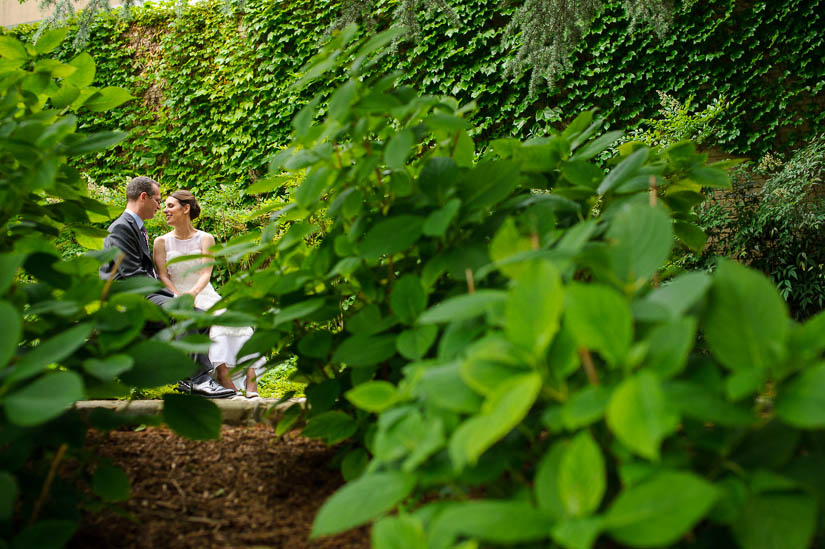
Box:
3 372 83 427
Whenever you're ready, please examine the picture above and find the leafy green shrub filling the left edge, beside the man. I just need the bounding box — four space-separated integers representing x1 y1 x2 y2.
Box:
0 34 225 547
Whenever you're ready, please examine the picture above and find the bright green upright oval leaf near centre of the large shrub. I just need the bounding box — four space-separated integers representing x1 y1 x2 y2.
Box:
504 261 564 357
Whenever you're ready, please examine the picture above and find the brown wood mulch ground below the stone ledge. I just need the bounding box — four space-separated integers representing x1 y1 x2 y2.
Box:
70 425 369 549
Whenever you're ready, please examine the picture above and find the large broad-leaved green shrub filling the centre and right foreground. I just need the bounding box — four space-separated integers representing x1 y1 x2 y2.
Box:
177 29 825 549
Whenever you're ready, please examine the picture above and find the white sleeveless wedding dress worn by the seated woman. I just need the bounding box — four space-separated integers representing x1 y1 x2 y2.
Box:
161 231 266 389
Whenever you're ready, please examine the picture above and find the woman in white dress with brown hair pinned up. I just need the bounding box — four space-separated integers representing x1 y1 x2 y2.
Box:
153 190 266 398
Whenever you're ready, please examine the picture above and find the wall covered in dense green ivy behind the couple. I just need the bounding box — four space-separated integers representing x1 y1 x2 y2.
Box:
8 0 825 192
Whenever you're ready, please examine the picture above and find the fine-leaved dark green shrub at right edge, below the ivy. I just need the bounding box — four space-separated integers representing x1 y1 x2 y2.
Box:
688 136 825 319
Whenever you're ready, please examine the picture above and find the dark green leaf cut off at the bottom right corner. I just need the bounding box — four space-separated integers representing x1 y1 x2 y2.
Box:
732 494 817 549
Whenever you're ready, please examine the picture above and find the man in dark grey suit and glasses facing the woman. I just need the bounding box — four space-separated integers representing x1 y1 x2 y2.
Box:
100 176 235 398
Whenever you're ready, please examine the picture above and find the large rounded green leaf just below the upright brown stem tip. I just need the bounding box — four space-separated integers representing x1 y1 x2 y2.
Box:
607 204 673 284
